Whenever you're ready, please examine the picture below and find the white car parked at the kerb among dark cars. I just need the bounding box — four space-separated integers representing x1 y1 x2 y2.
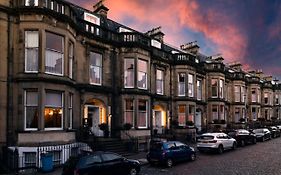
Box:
197 133 237 154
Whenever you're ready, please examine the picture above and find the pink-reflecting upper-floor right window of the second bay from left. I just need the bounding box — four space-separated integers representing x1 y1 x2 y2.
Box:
138 59 147 89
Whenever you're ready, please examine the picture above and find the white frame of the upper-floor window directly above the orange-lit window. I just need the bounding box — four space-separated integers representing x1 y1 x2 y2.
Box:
44 32 65 76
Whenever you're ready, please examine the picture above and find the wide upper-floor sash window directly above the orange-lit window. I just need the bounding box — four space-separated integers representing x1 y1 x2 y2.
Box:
45 32 64 75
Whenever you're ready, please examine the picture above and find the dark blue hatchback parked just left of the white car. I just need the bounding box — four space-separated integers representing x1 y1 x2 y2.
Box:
147 141 196 167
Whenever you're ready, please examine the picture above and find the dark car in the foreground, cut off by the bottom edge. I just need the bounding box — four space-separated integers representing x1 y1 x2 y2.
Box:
62 152 140 175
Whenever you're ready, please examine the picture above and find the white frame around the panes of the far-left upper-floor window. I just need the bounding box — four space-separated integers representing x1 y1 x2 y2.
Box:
24 30 39 73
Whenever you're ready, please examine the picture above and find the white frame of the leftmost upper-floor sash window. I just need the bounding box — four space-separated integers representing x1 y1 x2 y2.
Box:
24 30 40 73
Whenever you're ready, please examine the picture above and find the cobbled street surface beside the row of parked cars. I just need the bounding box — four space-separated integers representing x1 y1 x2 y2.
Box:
140 137 281 175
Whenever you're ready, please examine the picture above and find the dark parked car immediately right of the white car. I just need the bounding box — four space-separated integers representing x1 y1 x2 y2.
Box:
228 129 257 146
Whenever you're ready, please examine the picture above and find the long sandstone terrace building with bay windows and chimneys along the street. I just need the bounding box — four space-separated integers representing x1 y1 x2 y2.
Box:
0 0 281 170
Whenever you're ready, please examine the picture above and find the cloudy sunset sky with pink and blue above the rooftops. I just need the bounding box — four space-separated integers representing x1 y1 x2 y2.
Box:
68 0 281 79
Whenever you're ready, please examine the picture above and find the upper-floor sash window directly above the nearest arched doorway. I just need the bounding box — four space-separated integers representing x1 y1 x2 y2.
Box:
90 52 102 85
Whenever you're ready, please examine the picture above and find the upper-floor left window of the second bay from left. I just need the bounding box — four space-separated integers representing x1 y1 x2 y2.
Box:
124 58 135 88
